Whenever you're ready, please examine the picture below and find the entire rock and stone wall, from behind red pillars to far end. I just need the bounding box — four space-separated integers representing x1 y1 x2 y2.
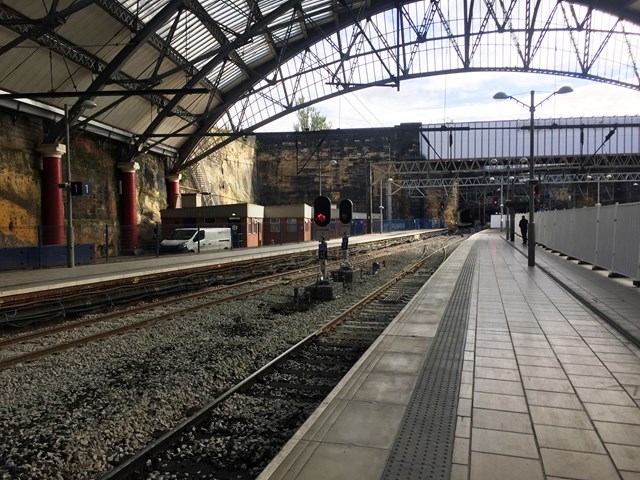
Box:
0 113 436 257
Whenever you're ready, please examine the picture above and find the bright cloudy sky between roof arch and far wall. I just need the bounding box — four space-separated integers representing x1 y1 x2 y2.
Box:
257 73 640 132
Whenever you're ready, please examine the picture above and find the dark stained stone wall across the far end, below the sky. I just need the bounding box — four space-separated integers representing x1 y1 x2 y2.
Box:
256 124 426 218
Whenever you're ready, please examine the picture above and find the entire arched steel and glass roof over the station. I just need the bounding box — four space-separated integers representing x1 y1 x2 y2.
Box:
0 0 640 170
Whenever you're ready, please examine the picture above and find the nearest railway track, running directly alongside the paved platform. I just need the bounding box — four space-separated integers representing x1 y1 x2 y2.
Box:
101 238 458 480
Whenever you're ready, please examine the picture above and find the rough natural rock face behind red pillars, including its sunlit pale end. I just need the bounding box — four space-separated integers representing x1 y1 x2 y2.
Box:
0 113 257 257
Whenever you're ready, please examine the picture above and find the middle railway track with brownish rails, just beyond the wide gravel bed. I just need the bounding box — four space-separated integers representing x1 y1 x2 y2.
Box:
0 238 450 370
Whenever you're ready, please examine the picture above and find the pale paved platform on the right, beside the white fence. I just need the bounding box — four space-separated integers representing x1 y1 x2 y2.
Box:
259 231 640 480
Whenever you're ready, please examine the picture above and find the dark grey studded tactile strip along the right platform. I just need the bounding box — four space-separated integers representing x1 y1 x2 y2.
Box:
382 246 476 480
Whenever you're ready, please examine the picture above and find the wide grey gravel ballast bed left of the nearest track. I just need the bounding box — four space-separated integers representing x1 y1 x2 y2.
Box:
0 238 444 480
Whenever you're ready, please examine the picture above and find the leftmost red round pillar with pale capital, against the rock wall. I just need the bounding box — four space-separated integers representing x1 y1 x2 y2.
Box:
38 143 67 245
